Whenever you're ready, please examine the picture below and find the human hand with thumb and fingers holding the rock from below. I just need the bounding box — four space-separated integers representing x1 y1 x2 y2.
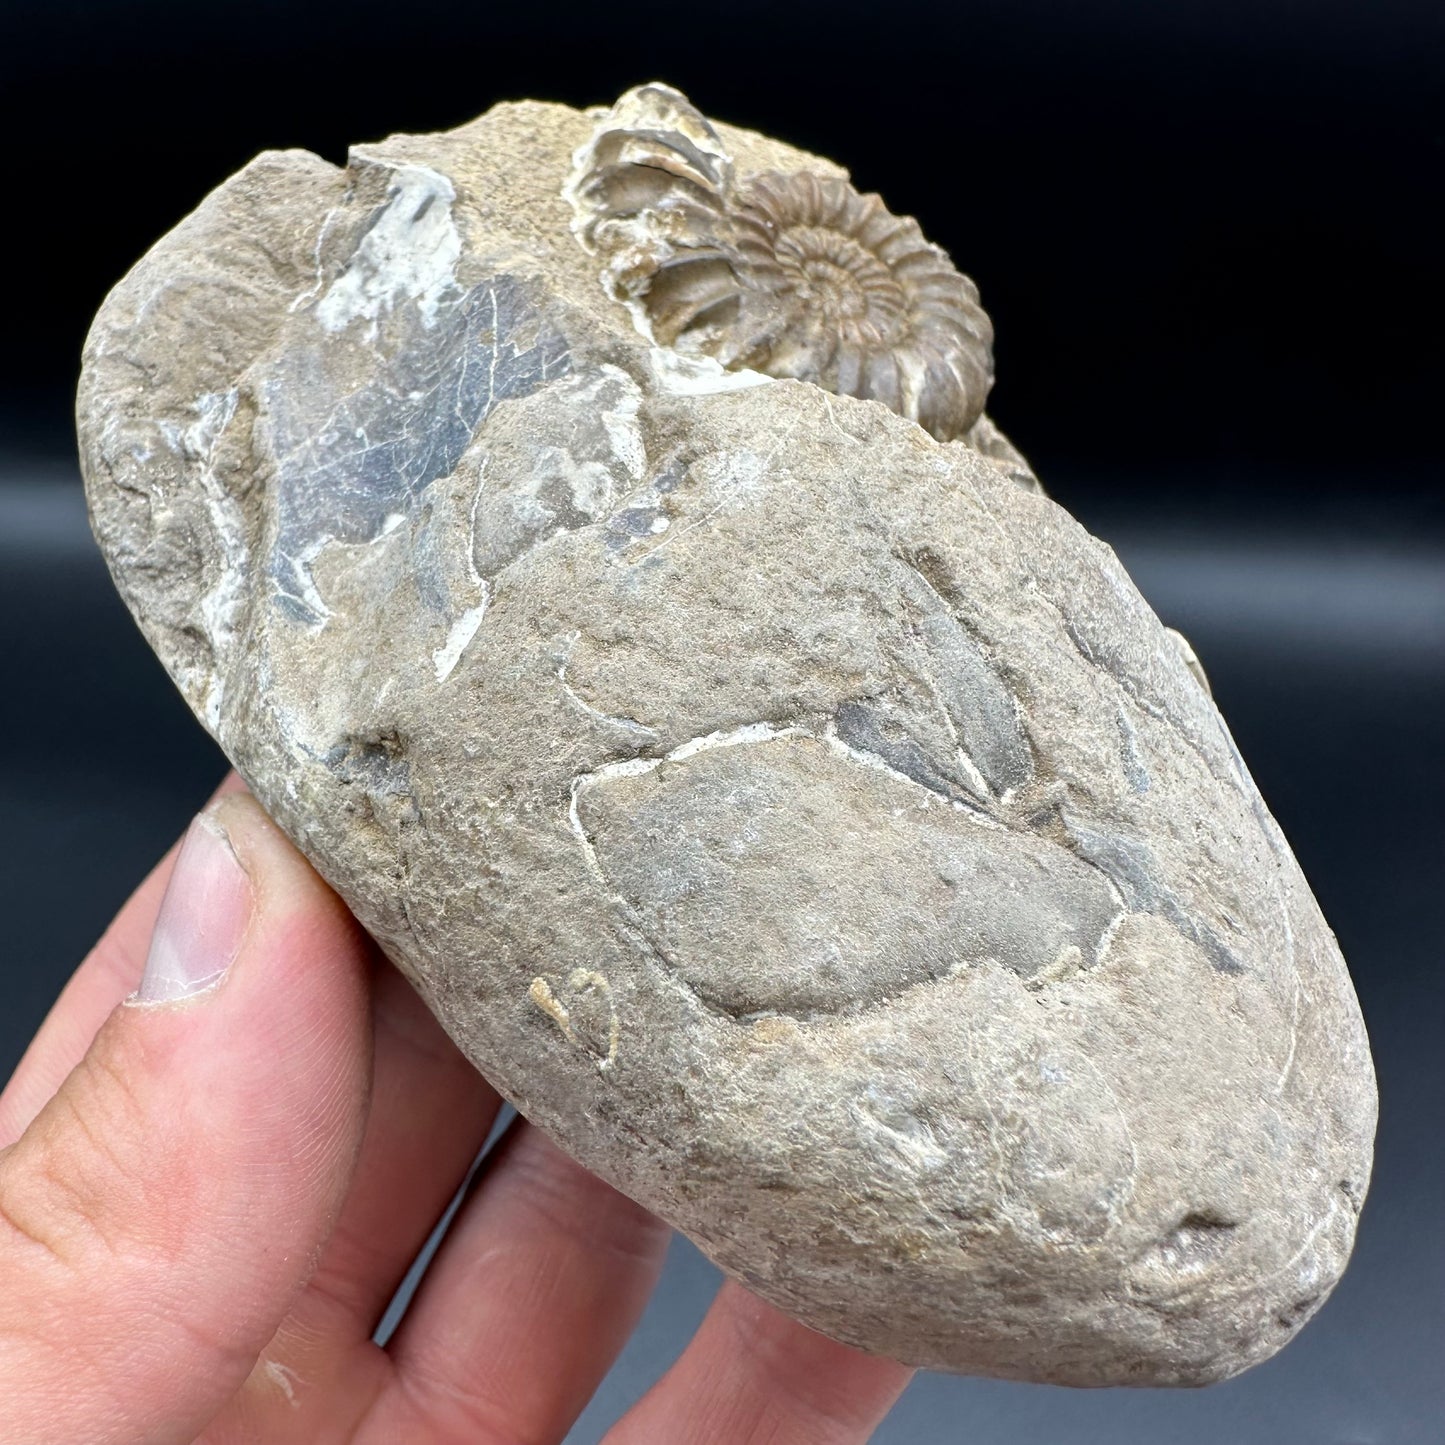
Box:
0 782 909 1445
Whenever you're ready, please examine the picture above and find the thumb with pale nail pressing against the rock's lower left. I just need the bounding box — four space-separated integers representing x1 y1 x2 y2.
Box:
0 793 370 1445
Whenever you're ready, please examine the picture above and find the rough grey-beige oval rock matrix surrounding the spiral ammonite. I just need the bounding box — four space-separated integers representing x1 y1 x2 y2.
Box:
79 84 1376 1384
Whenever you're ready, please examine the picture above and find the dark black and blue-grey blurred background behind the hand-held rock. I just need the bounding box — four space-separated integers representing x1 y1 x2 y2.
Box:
0 0 1445 1445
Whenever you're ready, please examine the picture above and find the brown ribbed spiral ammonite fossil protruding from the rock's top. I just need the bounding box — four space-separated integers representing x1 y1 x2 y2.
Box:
571 85 993 441
